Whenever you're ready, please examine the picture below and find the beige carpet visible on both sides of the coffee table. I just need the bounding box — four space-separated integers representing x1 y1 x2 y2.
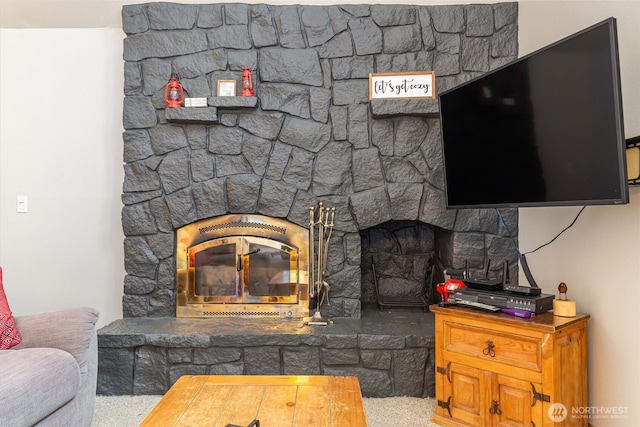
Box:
91 396 437 427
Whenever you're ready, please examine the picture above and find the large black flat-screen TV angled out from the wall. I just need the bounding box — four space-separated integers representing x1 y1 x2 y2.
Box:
439 18 629 209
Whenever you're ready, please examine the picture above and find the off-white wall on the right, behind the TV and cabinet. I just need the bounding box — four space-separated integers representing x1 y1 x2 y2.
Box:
519 1 640 427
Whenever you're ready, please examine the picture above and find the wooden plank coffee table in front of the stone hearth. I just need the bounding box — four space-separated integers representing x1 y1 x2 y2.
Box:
140 375 367 427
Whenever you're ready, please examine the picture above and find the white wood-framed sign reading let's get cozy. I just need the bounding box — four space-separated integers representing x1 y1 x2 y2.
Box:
369 71 436 100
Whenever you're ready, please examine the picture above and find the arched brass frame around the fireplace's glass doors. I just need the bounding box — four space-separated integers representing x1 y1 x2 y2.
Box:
176 215 309 318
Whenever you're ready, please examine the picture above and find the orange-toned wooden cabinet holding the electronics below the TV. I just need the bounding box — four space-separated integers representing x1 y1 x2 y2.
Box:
430 305 589 427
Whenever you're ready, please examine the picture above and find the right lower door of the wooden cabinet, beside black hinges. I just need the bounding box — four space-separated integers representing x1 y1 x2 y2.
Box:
489 374 542 427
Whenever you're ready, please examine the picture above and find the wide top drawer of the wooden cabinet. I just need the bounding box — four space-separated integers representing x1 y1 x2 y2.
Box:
443 321 542 372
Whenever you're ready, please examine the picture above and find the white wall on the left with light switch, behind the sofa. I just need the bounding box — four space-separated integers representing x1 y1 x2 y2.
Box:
0 29 124 325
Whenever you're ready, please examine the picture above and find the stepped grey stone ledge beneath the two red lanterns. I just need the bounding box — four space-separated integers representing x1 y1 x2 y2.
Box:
165 96 258 125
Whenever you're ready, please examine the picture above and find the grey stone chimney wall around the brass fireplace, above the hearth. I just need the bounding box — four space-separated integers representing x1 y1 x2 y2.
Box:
122 3 517 318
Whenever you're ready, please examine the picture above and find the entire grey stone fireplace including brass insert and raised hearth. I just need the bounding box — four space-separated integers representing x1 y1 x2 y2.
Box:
98 3 518 397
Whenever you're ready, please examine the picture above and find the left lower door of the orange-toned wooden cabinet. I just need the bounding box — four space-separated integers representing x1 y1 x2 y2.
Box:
443 363 488 427
